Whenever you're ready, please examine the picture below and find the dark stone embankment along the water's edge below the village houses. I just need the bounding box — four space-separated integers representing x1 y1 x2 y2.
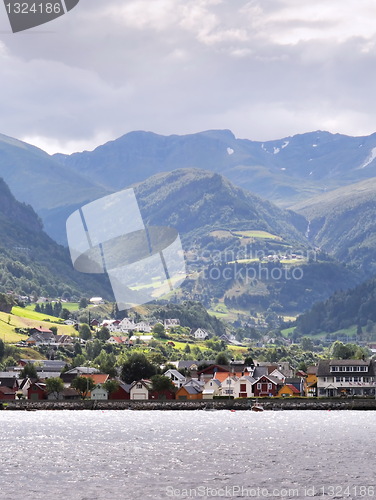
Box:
0 398 376 411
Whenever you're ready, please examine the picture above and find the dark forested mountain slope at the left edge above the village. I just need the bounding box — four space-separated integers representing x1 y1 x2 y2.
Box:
0 179 112 298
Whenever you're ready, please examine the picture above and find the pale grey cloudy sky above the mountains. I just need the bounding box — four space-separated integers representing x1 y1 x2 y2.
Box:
0 0 376 153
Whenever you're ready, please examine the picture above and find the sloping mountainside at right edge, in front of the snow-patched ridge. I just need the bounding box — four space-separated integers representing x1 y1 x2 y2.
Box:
293 177 376 276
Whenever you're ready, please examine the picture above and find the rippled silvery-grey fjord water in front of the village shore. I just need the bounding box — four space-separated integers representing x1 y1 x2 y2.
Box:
0 410 376 500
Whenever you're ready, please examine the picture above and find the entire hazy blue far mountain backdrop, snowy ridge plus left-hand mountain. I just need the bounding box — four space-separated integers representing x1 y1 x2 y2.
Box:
0 130 376 247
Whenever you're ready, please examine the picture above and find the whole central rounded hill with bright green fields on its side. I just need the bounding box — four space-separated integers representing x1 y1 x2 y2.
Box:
135 169 362 313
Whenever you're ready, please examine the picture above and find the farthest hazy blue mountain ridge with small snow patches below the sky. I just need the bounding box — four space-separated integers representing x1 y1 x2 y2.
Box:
55 130 376 206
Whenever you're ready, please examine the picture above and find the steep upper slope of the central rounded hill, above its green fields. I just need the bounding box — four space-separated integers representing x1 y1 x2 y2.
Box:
135 169 307 245
